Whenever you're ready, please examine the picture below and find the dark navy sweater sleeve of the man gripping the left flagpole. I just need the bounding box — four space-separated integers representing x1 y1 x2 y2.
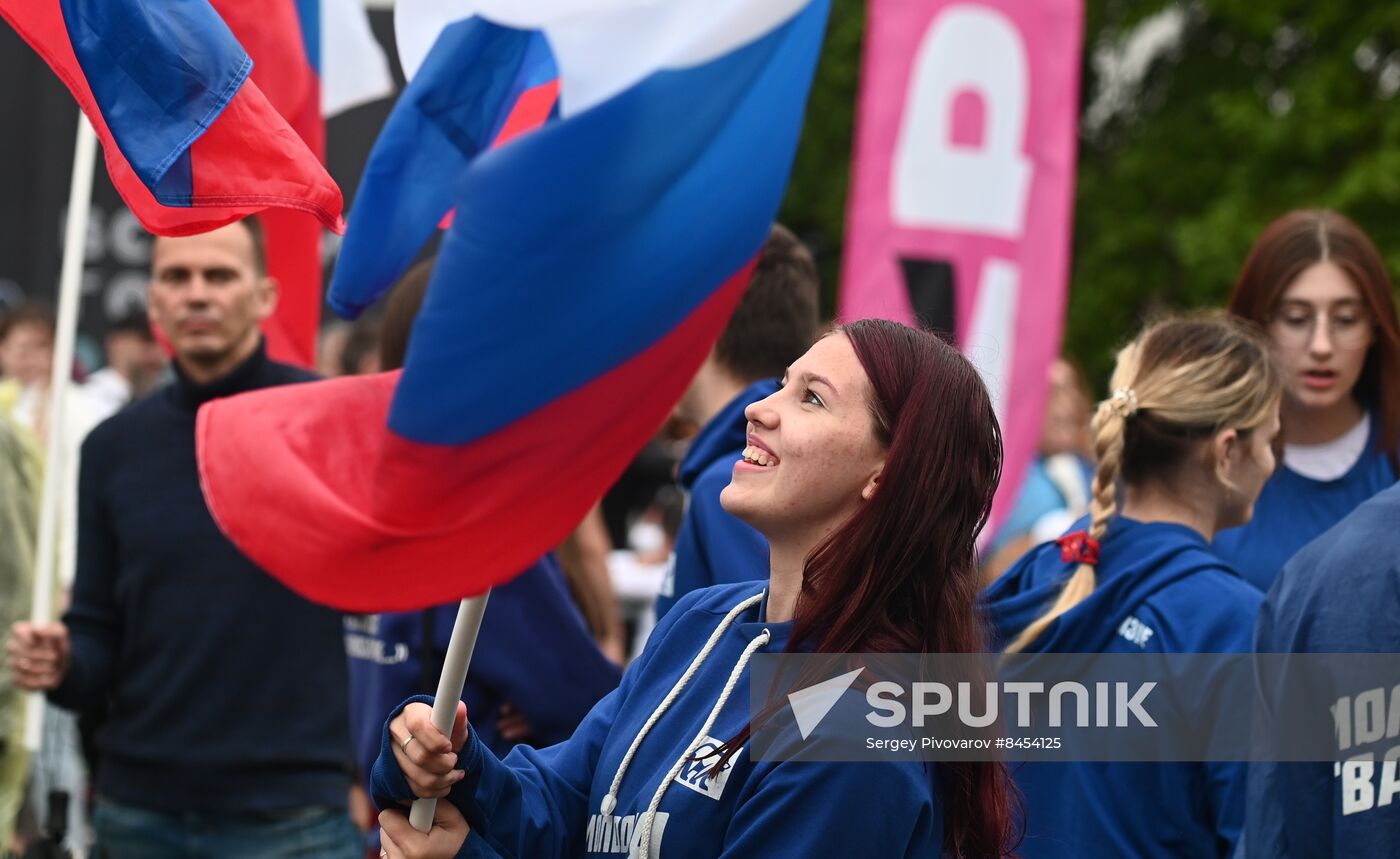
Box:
49 427 122 711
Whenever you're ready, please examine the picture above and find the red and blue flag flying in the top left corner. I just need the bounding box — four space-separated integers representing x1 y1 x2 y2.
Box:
0 0 343 235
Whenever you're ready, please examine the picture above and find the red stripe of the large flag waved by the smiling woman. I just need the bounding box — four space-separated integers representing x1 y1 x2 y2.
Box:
196 262 753 611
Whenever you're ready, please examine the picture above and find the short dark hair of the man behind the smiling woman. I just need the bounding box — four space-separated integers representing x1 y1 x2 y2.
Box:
714 224 822 383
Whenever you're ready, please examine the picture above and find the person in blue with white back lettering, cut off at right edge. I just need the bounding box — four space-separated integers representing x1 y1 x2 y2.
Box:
1245 485 1400 859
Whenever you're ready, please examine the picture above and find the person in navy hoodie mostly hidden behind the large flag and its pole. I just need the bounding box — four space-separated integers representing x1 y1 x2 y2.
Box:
344 260 622 851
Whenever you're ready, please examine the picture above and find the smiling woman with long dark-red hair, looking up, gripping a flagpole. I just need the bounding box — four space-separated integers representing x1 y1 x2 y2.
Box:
374 320 1014 859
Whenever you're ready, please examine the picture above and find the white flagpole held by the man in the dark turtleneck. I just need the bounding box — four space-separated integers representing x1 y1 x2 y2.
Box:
24 111 97 751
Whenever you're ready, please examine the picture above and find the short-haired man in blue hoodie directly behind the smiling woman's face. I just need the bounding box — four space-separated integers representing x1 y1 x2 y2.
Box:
657 224 822 620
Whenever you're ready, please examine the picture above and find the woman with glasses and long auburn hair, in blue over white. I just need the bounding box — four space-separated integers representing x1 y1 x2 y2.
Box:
1215 210 1400 590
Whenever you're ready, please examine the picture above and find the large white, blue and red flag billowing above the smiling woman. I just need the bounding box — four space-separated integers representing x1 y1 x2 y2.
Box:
197 0 826 610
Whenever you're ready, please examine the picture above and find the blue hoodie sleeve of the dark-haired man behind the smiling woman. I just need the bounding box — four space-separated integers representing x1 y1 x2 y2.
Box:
657 463 769 618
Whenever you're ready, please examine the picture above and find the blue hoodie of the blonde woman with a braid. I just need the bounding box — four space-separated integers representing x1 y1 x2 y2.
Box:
984 516 1263 859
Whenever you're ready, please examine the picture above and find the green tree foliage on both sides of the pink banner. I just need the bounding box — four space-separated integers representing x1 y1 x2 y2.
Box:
783 0 1400 388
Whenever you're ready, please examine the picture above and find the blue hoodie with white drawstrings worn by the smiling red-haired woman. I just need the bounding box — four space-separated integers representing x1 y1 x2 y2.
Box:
374 582 942 858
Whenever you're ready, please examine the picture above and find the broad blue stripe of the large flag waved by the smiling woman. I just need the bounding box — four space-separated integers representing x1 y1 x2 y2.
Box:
392 0 827 443
